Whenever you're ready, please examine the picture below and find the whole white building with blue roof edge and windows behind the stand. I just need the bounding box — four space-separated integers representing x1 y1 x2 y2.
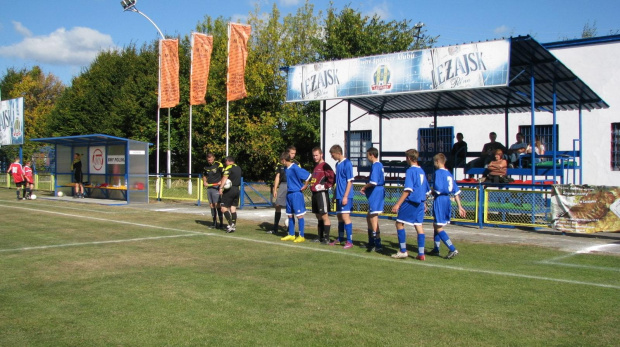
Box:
314 35 620 186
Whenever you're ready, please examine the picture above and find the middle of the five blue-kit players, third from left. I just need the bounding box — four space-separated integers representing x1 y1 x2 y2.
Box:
361 147 385 252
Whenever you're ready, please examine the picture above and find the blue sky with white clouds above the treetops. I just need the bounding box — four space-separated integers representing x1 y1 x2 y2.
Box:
0 0 620 85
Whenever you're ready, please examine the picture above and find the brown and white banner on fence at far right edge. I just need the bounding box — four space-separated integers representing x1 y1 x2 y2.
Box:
551 185 620 234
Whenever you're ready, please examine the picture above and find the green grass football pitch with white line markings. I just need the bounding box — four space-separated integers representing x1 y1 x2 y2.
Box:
0 189 620 346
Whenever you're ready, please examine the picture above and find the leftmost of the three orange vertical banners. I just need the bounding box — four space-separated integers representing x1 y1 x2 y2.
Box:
159 39 181 108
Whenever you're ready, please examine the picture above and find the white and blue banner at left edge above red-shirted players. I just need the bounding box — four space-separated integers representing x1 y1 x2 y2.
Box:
0 98 24 146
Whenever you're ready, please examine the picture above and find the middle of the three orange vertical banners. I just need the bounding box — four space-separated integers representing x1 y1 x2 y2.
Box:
189 33 213 105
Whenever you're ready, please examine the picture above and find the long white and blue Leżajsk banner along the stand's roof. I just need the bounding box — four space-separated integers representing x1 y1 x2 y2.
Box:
286 40 510 102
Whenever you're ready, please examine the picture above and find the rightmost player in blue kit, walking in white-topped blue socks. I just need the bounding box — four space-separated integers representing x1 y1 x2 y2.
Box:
429 153 466 259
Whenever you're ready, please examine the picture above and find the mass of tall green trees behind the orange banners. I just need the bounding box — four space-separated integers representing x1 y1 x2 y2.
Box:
38 0 436 180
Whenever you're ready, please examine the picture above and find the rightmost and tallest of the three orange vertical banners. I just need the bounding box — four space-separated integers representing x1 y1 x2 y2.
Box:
226 23 252 101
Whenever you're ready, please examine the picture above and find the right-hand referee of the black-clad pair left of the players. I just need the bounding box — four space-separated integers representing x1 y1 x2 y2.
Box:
220 157 243 233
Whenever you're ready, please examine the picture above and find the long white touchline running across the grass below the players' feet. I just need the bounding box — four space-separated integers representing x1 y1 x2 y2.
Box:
3 205 620 289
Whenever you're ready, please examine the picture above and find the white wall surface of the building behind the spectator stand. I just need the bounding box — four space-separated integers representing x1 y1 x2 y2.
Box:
321 38 620 186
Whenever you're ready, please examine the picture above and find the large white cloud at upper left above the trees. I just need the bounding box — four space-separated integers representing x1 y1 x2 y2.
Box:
0 22 115 65
